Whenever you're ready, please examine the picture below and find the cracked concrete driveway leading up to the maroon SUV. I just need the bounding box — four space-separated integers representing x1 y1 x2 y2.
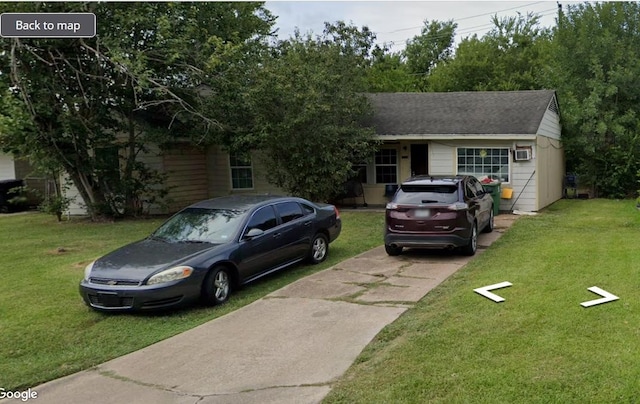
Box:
32 215 517 404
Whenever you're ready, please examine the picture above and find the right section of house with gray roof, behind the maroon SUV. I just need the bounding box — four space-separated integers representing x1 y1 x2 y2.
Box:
363 90 565 211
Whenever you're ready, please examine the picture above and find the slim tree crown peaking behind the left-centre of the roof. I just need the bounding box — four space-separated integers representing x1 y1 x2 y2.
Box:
403 20 458 91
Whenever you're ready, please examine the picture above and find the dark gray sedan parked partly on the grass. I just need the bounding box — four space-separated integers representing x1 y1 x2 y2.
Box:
80 195 342 311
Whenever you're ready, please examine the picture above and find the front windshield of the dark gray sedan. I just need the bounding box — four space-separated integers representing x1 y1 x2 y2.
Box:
151 208 245 244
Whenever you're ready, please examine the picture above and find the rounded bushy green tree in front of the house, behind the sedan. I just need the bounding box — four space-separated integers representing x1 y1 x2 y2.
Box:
244 23 375 201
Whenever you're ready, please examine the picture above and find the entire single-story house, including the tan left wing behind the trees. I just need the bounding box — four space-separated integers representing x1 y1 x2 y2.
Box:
62 90 565 214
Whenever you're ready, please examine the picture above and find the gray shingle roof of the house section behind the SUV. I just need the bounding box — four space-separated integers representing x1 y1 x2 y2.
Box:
367 90 555 135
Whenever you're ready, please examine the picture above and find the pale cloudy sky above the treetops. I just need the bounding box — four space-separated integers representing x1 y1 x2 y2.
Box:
265 0 576 52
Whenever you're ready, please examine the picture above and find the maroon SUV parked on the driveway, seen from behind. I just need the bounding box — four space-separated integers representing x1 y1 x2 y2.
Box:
384 175 493 255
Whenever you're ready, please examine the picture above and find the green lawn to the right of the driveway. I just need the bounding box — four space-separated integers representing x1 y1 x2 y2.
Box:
326 200 640 404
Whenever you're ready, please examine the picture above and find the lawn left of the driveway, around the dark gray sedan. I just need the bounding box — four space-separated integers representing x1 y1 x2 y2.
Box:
0 208 384 391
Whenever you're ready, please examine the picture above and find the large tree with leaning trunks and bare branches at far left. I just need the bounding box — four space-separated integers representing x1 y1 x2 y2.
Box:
0 3 273 218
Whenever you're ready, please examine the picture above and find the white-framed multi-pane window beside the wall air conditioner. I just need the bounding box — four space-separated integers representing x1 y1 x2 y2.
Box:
458 147 509 182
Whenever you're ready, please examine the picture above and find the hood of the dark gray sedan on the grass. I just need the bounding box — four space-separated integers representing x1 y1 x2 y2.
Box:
91 239 219 280
